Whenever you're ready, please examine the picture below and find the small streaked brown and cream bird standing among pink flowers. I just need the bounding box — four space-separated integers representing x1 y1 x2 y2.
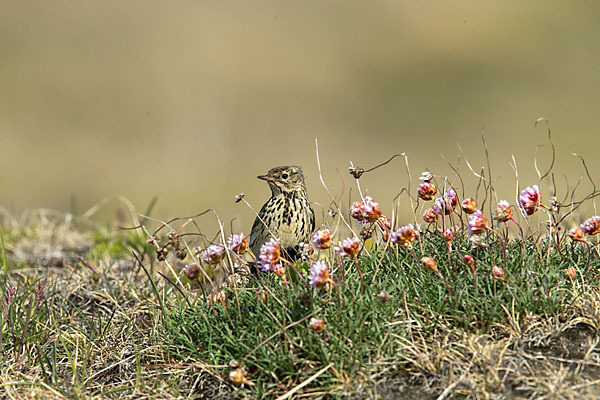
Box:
250 165 315 259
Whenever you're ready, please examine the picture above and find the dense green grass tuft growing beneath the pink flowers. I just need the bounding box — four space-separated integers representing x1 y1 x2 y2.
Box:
162 237 598 398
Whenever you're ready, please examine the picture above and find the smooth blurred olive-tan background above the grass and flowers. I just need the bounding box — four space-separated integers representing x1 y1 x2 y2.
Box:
0 0 600 232
